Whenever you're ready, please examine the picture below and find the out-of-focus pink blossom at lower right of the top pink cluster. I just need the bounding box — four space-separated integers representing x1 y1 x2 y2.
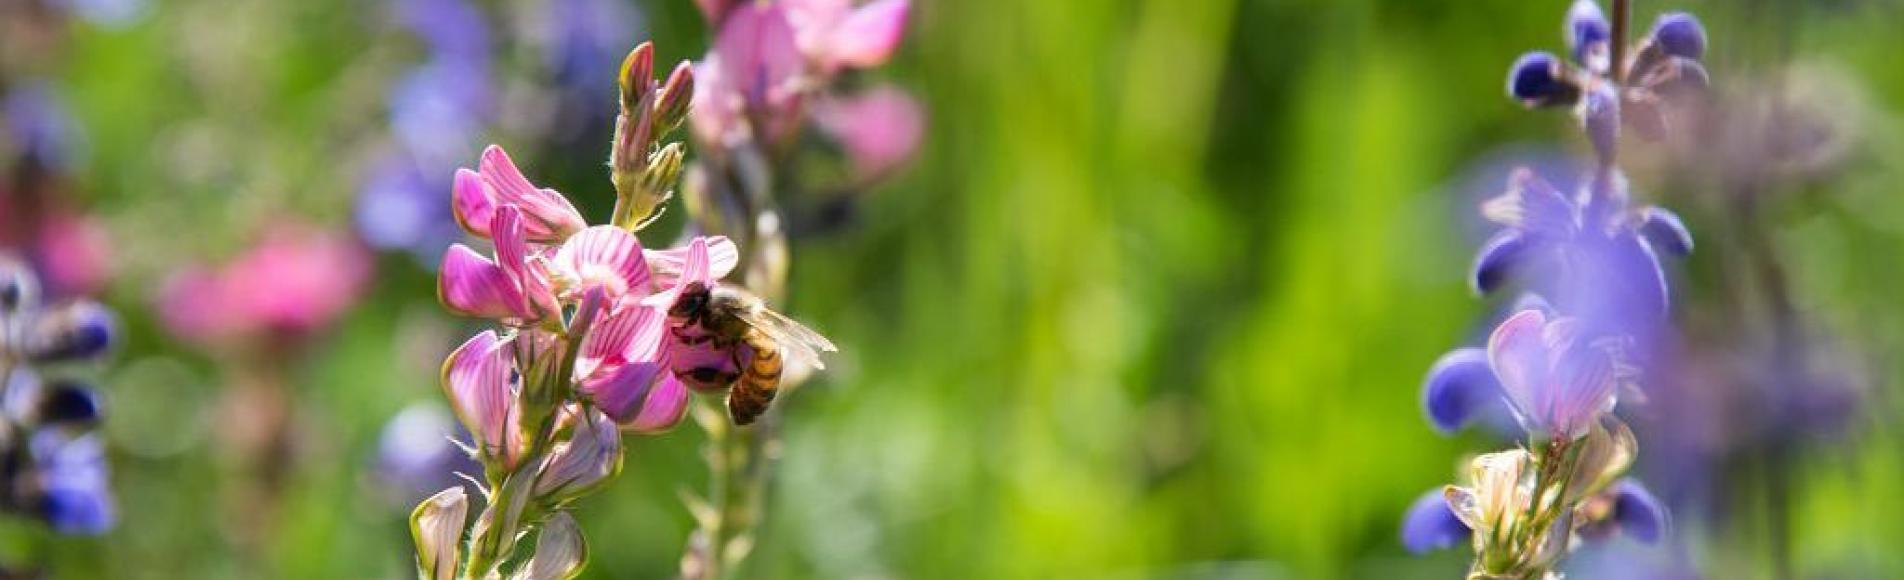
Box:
813 86 925 179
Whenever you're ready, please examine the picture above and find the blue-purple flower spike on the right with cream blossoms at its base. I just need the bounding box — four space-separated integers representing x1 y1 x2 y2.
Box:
1403 0 1708 578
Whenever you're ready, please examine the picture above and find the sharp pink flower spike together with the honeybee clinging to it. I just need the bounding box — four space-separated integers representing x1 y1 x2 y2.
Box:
411 44 830 578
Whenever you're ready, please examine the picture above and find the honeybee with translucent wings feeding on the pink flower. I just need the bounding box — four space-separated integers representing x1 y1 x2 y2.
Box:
668 283 838 424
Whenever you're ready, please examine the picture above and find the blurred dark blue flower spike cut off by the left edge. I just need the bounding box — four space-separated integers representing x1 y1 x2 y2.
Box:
0 255 118 534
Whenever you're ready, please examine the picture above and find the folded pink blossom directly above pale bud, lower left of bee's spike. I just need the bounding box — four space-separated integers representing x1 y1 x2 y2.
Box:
442 331 522 466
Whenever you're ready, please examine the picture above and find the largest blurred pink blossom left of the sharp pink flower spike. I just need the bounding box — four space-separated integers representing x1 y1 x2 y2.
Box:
158 224 371 342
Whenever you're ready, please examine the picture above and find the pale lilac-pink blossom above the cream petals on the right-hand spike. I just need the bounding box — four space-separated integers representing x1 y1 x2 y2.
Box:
1487 310 1632 439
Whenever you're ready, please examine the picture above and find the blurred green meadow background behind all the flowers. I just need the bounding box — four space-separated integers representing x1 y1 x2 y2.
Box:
4 0 1904 578
